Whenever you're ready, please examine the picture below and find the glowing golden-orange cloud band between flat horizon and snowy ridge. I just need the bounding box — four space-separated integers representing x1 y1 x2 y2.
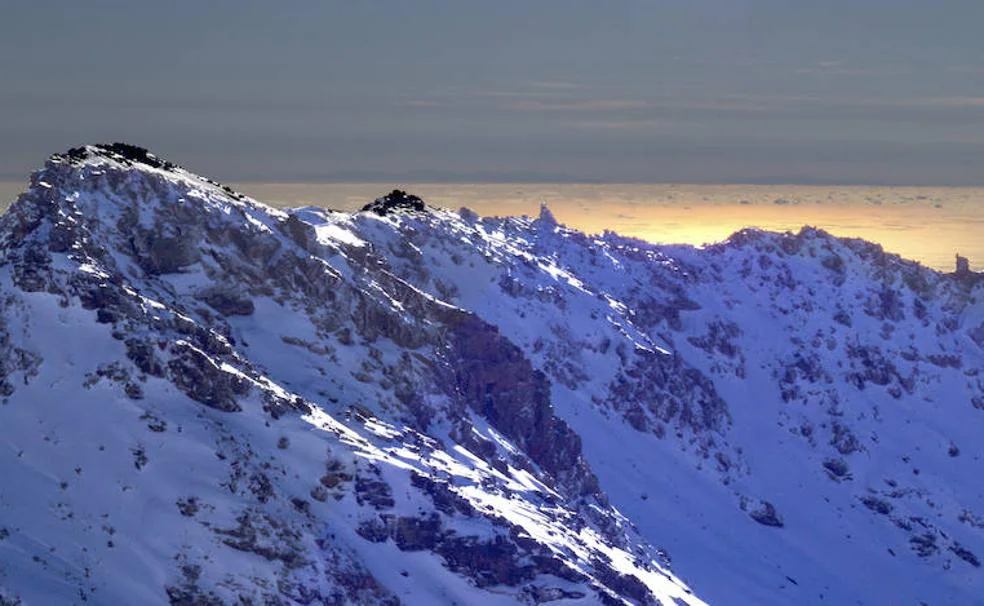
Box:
238 183 984 271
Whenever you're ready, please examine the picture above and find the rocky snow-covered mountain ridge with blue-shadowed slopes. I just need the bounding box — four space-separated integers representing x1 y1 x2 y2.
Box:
0 144 984 605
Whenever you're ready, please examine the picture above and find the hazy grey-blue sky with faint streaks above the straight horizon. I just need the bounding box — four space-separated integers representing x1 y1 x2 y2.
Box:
0 0 984 184
